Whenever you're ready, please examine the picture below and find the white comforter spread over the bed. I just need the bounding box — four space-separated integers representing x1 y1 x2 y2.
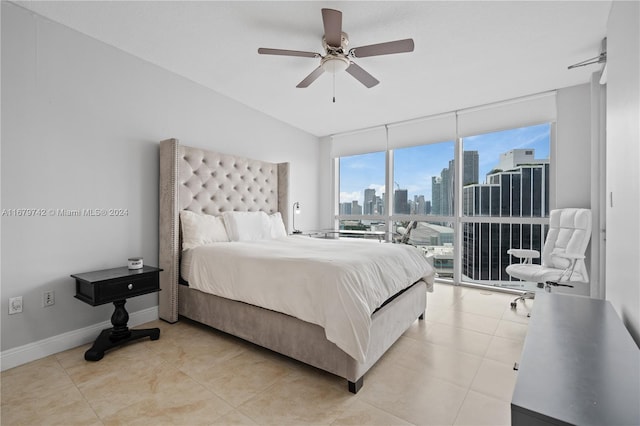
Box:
189 236 434 362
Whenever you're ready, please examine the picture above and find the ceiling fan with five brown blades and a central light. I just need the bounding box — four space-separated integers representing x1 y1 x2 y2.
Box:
258 9 413 88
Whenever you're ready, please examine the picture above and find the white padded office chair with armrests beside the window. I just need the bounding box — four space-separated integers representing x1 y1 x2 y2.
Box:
506 209 591 309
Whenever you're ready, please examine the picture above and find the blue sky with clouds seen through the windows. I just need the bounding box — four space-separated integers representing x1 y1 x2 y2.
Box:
340 124 551 205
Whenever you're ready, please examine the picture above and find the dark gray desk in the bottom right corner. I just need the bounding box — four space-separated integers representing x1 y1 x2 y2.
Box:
511 293 640 425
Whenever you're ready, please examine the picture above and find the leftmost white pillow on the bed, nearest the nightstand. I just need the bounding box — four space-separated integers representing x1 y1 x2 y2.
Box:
180 210 229 250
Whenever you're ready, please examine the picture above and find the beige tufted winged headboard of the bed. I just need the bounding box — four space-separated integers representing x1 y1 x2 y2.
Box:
158 139 289 322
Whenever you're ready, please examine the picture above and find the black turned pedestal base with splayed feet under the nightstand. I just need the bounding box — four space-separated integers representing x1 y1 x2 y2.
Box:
84 300 160 361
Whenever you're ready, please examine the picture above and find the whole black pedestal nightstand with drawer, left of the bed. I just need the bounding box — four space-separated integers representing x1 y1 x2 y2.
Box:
71 266 162 361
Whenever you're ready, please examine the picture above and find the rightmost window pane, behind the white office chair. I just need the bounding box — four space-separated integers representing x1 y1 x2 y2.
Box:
462 124 551 287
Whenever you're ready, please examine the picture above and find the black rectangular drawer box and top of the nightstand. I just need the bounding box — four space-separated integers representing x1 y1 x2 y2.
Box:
72 266 160 306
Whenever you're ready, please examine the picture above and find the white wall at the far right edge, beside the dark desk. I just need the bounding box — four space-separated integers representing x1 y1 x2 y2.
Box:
606 1 640 345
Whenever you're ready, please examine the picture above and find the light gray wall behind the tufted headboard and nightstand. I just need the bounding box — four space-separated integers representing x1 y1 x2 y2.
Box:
1 2 320 351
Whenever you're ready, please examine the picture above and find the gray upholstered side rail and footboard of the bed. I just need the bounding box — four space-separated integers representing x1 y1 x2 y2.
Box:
178 281 427 393
